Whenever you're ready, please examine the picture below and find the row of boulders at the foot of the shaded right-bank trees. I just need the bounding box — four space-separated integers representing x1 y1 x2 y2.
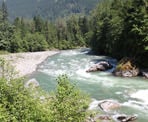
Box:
86 58 148 78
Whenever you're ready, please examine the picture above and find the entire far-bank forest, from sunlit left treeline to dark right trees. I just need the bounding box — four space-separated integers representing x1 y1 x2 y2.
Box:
0 0 148 66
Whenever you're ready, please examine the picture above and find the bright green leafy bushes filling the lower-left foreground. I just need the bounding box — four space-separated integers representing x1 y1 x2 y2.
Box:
0 59 88 122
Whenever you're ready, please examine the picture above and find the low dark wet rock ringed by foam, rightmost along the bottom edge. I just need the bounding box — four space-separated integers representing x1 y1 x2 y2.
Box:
113 115 137 122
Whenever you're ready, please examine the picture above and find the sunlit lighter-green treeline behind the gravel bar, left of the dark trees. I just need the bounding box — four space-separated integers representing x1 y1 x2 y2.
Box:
0 0 90 53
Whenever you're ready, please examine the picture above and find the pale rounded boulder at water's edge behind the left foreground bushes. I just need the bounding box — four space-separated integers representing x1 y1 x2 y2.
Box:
25 78 40 88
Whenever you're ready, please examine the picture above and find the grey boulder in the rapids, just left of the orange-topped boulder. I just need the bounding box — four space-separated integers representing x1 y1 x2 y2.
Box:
86 61 113 72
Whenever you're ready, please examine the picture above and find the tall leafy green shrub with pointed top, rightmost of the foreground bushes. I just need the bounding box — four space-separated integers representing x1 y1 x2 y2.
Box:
51 75 88 122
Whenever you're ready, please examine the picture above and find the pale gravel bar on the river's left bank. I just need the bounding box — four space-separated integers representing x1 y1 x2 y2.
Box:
1 51 59 76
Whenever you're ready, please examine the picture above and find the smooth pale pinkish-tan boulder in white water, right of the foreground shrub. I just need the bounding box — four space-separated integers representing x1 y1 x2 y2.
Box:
98 100 121 112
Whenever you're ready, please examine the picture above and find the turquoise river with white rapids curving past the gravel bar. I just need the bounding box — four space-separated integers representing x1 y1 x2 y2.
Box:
31 49 148 122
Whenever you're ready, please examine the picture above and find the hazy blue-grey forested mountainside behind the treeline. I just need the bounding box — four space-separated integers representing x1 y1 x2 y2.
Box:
0 0 99 20
